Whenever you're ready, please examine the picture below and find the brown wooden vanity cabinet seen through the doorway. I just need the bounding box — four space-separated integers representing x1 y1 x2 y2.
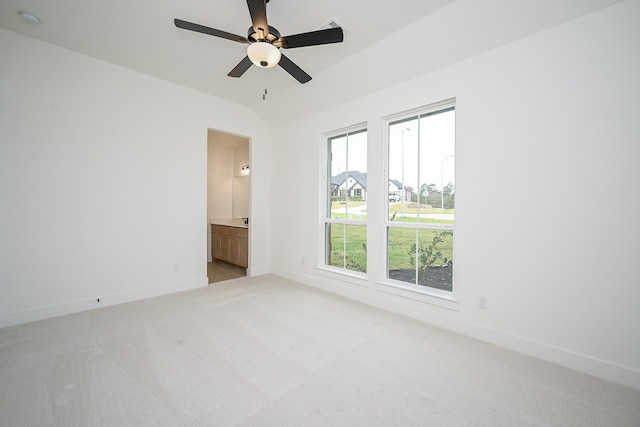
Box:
211 224 249 267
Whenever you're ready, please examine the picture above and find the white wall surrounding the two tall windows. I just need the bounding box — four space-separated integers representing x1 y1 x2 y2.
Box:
272 1 640 388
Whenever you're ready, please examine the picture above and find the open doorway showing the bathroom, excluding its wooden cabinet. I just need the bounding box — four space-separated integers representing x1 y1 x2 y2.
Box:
207 129 251 284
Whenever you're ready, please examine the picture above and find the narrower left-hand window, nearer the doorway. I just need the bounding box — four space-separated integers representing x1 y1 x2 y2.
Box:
324 129 368 273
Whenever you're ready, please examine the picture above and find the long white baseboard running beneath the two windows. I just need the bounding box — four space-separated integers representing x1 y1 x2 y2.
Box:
272 269 640 390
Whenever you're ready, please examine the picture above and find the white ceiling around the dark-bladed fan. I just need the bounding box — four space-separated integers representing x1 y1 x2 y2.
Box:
0 0 620 124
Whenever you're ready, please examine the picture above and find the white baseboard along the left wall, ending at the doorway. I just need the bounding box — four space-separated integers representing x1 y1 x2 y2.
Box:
0 277 209 328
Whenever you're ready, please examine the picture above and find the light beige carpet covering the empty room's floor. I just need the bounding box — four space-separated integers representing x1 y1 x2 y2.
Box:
0 275 640 427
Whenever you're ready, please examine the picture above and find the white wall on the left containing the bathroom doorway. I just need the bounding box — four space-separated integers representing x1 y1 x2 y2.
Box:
0 29 271 327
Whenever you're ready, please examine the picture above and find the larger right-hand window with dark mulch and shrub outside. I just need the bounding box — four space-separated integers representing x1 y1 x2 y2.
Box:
386 102 455 292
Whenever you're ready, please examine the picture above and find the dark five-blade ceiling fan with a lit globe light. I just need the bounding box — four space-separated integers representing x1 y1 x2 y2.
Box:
173 0 343 83
